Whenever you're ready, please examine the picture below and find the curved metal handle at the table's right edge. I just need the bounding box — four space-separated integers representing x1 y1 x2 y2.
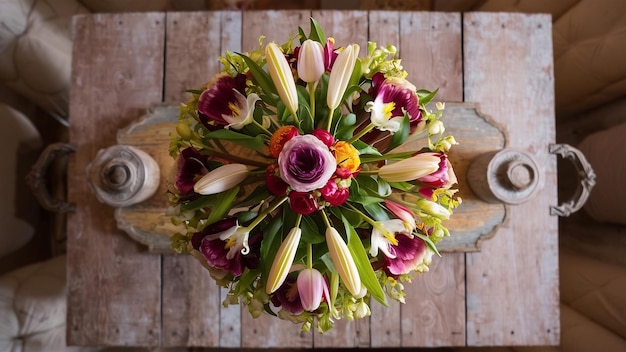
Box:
549 144 596 216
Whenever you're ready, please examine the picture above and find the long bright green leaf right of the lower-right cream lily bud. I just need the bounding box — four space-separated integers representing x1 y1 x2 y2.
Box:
341 217 388 306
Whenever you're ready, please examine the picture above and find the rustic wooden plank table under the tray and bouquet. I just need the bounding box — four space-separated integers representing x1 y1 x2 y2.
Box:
67 11 560 347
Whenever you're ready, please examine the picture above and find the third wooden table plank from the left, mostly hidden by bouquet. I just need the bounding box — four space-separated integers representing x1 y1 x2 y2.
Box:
241 10 313 348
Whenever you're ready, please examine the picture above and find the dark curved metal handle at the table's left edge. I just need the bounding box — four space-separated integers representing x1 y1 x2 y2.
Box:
26 143 76 213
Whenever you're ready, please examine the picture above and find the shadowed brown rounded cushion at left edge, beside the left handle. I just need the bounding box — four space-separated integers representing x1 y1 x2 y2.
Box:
0 103 42 257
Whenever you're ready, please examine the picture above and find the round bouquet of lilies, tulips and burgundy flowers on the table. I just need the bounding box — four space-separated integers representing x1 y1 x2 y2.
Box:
169 19 460 332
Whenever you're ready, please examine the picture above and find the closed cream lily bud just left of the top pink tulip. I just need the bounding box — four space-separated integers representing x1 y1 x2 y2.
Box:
265 43 298 120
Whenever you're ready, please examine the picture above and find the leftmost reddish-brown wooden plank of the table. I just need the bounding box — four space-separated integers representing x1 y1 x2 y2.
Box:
67 13 165 346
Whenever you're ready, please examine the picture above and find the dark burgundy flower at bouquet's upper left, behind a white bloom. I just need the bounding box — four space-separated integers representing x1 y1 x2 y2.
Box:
198 73 246 130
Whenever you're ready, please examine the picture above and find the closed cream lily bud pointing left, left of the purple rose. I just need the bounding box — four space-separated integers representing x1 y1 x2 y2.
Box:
193 164 248 195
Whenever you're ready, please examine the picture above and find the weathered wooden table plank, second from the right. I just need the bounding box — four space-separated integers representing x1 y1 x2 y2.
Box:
398 12 465 346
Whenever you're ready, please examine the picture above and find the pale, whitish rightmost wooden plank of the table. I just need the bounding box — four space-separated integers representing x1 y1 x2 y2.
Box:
463 13 560 345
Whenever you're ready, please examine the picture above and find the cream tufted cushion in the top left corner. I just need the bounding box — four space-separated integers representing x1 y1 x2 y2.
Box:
0 0 87 116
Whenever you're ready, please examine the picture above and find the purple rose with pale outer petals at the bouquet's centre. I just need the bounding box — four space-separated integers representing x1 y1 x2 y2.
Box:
278 134 337 192
